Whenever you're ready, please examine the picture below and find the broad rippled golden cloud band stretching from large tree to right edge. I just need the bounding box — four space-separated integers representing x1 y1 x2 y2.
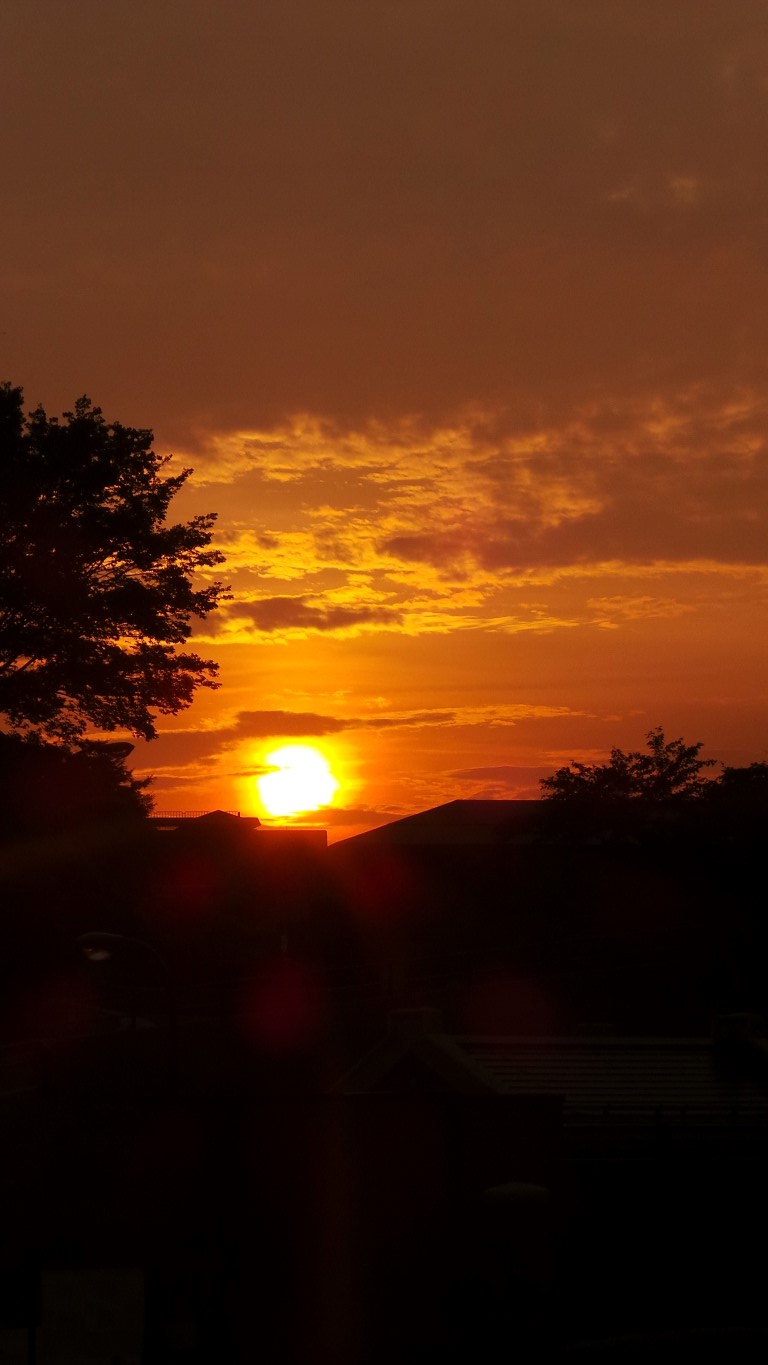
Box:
169 381 768 682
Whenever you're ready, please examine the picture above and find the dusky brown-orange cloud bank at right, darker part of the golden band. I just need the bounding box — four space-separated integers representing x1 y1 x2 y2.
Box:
378 392 768 575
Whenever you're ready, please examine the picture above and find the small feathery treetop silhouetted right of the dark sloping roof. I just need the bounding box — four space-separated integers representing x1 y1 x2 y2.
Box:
540 726 715 804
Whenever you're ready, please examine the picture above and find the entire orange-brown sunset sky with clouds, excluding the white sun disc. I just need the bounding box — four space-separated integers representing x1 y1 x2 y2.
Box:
0 0 768 839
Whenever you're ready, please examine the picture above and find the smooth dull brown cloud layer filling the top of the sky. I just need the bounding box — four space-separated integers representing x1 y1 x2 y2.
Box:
7 0 768 453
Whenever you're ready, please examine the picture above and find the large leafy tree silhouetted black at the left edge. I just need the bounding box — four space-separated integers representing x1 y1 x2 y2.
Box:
0 384 224 743
